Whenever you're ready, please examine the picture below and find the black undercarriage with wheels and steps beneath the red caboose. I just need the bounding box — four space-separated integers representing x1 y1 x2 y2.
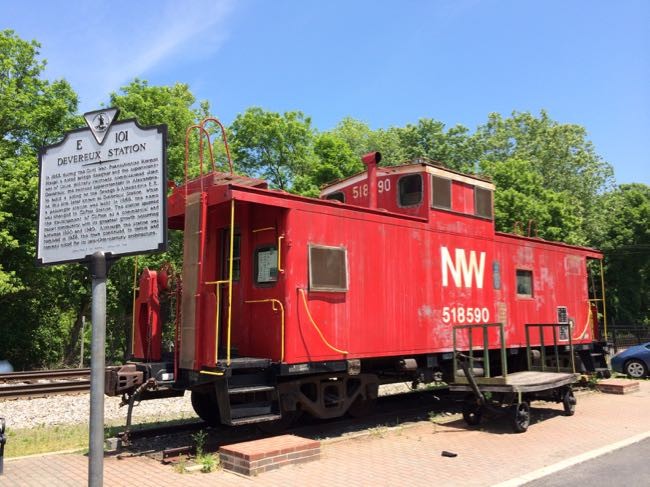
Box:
106 338 608 432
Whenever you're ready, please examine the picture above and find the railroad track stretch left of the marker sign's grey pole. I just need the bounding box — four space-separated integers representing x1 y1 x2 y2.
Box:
0 369 90 399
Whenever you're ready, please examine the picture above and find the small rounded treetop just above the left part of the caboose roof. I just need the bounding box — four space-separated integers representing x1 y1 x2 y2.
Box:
230 107 315 190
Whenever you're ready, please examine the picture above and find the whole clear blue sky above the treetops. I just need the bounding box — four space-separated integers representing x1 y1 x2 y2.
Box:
0 0 650 184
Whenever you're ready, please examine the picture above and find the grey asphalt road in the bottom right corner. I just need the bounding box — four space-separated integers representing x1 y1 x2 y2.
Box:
525 438 650 487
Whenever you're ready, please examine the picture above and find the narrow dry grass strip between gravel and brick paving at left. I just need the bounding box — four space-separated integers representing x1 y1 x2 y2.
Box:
5 418 196 458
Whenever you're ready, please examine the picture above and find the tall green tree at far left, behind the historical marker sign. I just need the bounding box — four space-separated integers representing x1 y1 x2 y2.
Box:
0 30 85 368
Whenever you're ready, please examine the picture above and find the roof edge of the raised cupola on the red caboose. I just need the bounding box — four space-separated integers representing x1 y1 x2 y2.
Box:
321 157 494 196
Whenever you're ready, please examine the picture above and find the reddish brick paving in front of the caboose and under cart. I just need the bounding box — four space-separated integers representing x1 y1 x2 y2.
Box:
5 381 650 487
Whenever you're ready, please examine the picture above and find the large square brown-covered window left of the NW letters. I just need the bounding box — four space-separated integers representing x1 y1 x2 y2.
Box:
309 245 348 291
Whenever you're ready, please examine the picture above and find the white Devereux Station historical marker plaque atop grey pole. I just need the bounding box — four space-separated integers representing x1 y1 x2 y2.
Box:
36 108 167 265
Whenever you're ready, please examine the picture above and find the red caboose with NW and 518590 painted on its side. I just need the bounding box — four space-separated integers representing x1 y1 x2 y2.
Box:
107 139 602 425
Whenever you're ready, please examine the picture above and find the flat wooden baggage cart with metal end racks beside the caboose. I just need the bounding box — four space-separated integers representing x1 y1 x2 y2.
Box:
449 323 579 433
